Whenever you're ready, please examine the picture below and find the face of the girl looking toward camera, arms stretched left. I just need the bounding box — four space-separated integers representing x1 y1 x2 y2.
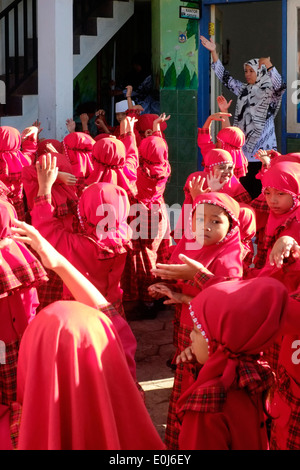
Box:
192 203 230 246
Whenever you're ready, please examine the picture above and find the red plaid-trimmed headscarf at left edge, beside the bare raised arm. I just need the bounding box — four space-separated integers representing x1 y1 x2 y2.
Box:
0 200 48 297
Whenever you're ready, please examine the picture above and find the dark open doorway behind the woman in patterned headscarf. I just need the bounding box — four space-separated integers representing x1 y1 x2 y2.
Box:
199 0 282 151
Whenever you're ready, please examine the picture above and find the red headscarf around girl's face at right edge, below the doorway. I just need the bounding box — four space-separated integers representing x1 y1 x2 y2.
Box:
262 161 300 247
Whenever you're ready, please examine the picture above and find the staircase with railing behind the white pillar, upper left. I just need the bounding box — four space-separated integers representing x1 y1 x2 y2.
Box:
0 0 134 129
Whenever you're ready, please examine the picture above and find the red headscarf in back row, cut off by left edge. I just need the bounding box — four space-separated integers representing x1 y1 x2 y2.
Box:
0 126 31 177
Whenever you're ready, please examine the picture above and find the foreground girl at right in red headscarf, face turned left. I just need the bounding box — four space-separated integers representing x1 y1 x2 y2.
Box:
177 278 288 450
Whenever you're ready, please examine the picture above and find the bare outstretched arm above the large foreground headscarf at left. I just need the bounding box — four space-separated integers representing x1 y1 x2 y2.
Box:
12 219 108 308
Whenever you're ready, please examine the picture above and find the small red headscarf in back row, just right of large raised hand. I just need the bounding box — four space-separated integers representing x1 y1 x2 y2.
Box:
63 132 95 178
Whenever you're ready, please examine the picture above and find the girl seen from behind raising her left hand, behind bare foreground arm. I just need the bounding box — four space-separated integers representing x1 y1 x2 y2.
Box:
31 154 131 315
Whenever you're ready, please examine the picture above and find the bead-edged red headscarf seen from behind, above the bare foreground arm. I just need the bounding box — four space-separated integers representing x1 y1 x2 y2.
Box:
78 183 132 253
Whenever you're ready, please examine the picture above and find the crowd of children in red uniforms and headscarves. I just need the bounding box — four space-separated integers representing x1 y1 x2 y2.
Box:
0 79 300 450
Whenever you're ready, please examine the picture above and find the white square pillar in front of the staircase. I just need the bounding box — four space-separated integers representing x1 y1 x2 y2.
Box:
38 0 73 140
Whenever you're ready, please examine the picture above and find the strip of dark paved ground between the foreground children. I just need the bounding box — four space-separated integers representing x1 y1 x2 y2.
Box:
129 310 174 439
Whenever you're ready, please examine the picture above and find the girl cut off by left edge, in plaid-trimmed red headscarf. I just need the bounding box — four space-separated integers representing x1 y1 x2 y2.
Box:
0 199 47 450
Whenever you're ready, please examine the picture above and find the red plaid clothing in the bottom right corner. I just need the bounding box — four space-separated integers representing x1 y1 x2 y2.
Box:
270 365 300 450
